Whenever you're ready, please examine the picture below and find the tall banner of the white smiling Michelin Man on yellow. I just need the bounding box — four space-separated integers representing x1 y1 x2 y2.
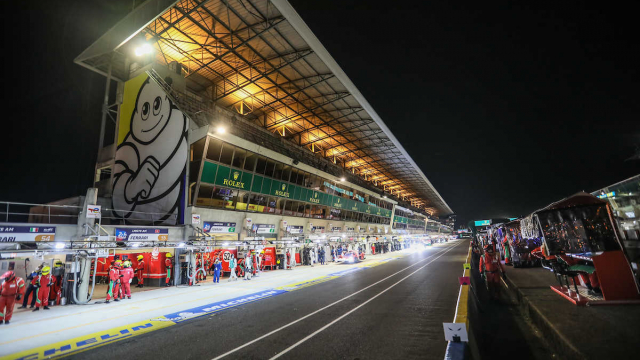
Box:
113 73 189 224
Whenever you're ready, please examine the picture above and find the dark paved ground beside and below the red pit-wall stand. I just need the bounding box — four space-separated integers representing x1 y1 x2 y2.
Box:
506 267 640 360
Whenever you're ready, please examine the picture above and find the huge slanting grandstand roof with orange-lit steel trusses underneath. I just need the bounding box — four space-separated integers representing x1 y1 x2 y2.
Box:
75 0 452 216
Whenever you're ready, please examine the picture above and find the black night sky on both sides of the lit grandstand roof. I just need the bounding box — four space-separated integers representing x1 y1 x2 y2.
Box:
0 0 640 228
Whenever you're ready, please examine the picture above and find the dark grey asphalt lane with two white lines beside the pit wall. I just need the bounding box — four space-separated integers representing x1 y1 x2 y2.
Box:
69 240 469 360
